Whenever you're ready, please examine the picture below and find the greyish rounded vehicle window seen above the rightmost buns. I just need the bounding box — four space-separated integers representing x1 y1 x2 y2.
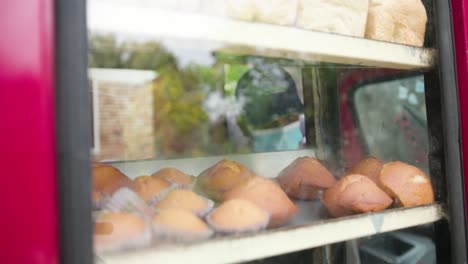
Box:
354 76 428 167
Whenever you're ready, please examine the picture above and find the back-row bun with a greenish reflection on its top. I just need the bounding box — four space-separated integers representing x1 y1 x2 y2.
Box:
197 160 255 201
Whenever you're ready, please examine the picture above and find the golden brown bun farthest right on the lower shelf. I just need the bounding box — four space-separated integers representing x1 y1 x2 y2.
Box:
379 161 434 207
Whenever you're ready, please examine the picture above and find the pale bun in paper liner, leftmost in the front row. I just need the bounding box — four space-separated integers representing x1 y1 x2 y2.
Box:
94 212 150 251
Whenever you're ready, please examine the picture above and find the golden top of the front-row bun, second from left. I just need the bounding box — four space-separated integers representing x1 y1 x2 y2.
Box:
152 209 210 233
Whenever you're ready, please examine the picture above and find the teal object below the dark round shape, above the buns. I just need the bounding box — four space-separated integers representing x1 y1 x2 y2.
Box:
252 122 303 152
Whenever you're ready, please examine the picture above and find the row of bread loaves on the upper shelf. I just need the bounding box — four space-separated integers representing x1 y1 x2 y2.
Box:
159 0 427 46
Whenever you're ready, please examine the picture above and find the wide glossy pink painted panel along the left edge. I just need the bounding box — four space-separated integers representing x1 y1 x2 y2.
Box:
0 0 59 264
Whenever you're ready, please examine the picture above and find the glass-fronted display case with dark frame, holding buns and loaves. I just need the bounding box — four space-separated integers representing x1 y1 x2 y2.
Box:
1 0 466 264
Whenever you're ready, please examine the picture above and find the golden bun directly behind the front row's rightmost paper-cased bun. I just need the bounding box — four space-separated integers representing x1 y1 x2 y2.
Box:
224 177 297 227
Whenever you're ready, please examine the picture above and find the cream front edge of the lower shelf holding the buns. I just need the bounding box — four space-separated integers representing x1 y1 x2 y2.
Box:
99 202 444 264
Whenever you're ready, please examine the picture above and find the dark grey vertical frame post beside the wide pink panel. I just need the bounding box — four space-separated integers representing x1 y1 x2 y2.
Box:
55 0 94 264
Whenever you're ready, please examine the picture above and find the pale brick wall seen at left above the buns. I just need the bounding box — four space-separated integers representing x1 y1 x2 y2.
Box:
94 81 155 160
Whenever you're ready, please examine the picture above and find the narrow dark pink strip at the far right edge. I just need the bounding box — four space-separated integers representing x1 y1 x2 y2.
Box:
452 0 468 225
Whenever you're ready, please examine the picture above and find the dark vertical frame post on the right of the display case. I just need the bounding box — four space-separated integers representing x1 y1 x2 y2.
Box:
434 0 467 263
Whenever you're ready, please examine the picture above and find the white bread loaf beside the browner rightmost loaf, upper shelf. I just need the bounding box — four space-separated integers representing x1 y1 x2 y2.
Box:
296 0 370 37
